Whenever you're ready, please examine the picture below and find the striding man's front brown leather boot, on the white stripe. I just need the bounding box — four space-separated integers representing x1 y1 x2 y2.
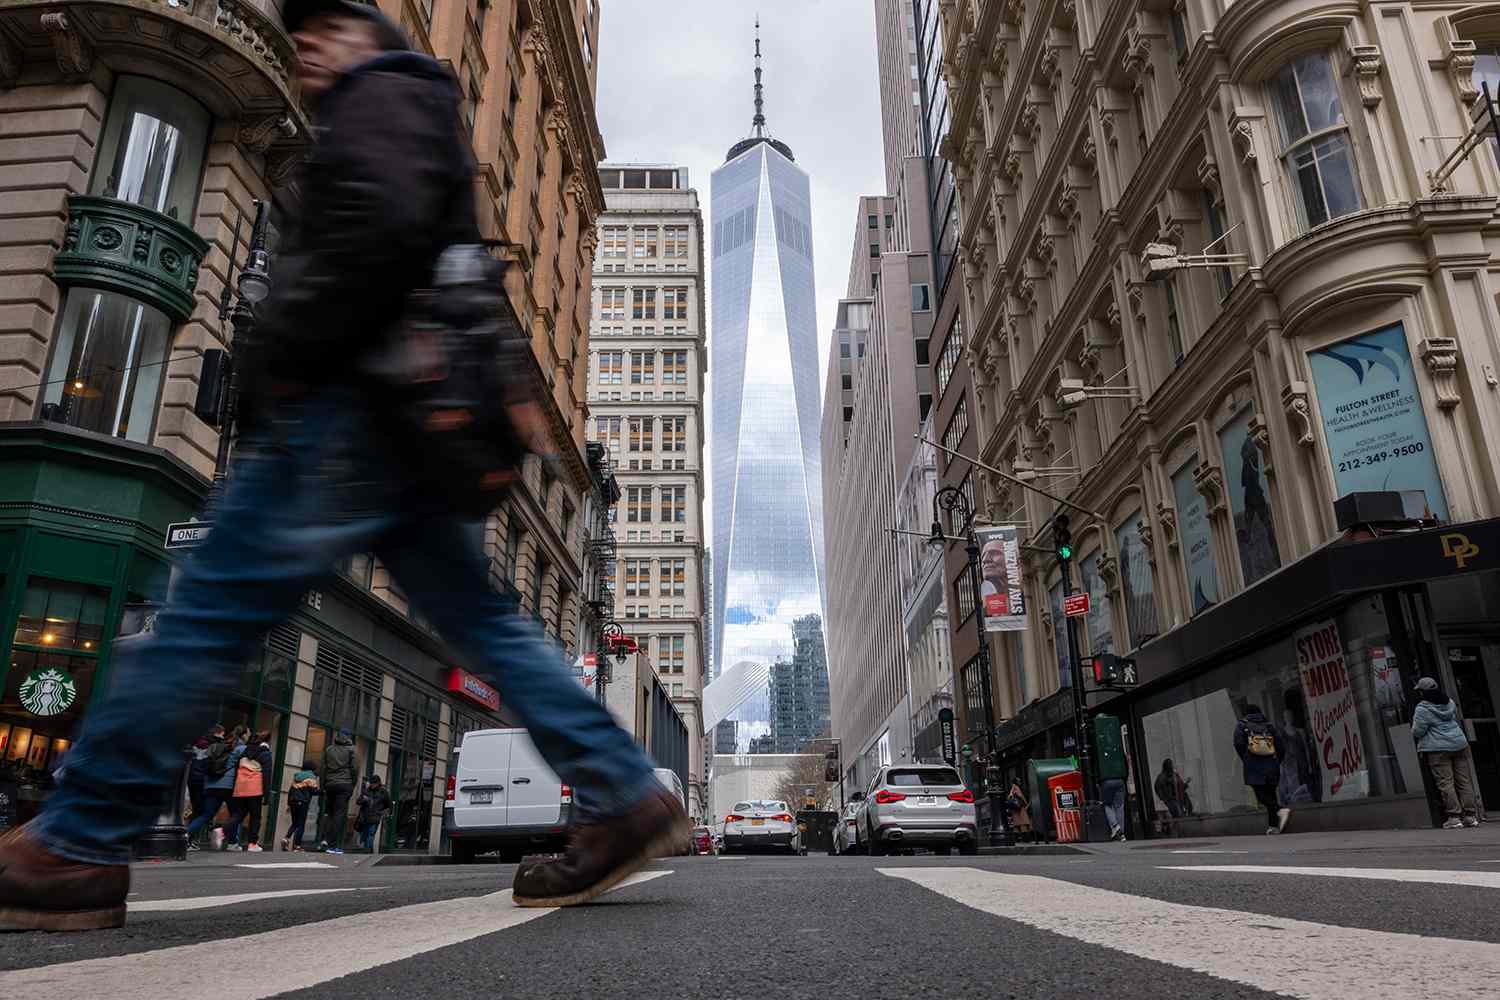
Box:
512 792 690 906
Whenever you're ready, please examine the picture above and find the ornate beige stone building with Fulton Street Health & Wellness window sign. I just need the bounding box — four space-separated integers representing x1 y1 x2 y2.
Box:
938 0 1500 832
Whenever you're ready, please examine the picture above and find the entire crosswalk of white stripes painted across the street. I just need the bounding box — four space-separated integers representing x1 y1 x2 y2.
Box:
0 859 1500 1000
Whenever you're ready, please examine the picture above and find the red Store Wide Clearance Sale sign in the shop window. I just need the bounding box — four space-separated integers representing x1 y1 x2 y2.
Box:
1293 621 1370 802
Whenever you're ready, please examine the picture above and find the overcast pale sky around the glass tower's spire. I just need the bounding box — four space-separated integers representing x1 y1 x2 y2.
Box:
599 0 885 390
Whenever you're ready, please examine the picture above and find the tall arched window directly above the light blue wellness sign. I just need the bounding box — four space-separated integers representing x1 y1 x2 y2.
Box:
1272 52 1359 226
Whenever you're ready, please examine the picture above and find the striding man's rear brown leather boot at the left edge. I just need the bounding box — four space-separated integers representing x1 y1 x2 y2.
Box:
0 826 131 931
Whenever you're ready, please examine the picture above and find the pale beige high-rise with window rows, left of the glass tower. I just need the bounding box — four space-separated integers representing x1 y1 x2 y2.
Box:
588 163 708 816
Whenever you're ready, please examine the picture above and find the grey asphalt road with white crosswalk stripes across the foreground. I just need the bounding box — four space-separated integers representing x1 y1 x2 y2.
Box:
0 825 1500 1000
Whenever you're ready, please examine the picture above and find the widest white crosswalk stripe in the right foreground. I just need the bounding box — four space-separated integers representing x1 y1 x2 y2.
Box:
879 868 1500 1000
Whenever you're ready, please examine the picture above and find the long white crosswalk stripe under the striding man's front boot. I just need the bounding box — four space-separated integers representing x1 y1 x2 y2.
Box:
0 871 672 1000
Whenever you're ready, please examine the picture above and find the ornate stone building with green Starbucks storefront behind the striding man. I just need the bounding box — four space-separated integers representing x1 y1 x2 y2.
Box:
0 0 608 850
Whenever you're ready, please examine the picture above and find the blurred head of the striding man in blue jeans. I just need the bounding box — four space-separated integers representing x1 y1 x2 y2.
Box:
282 0 408 103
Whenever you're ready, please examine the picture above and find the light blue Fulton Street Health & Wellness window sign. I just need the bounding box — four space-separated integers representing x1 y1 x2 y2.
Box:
1308 322 1448 520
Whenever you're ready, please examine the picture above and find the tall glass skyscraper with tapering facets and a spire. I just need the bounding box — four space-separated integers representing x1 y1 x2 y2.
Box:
705 25 824 751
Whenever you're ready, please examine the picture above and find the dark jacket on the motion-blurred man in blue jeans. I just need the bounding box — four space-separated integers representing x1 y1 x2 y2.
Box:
245 51 479 422
